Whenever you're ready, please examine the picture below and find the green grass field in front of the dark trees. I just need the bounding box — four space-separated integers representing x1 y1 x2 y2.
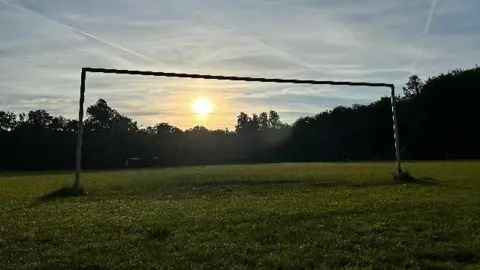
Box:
0 162 480 269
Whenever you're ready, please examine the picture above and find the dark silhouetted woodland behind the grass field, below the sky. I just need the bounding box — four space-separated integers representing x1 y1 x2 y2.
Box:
0 66 480 170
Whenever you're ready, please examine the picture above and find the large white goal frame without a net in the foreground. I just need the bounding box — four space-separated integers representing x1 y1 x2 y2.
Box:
73 67 402 190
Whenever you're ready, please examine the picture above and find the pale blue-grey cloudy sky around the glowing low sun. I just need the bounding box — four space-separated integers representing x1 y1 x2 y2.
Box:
0 0 480 129
